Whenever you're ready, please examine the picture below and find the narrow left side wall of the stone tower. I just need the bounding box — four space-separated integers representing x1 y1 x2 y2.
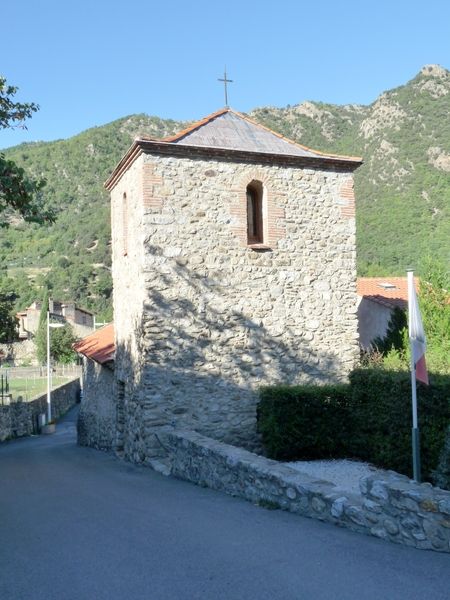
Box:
111 157 149 462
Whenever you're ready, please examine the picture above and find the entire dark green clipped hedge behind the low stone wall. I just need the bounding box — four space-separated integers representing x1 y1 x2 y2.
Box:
258 368 450 480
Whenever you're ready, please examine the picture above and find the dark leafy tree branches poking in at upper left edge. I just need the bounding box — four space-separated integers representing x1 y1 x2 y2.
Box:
0 76 55 227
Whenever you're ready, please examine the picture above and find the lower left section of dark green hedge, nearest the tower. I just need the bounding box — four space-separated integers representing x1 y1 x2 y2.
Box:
258 385 349 460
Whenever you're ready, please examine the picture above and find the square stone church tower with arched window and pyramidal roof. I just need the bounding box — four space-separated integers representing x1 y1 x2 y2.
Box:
106 108 361 454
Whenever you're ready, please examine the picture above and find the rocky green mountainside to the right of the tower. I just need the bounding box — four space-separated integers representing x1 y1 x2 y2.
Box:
252 65 450 275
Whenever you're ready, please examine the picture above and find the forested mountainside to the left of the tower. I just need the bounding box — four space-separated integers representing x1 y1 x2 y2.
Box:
0 115 184 320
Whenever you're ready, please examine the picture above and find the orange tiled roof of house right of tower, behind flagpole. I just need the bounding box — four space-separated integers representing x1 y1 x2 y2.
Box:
357 277 419 308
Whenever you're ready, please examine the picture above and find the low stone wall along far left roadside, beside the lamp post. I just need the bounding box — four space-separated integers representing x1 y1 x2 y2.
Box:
0 379 80 442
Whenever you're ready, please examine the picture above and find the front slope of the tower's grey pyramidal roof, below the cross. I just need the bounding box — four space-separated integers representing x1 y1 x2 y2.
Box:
159 108 361 161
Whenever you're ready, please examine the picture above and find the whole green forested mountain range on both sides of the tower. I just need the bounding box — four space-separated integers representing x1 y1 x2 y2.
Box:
0 66 450 318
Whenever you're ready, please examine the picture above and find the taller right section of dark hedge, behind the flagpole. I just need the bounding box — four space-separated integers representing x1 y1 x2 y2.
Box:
350 369 450 479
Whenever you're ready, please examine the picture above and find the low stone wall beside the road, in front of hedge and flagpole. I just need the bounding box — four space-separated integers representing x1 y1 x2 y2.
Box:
145 427 450 552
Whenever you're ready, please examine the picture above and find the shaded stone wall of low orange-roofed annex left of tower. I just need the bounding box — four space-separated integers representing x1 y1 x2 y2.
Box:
77 357 116 450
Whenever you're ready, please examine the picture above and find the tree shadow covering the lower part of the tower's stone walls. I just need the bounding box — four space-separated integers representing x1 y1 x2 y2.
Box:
112 247 348 454
